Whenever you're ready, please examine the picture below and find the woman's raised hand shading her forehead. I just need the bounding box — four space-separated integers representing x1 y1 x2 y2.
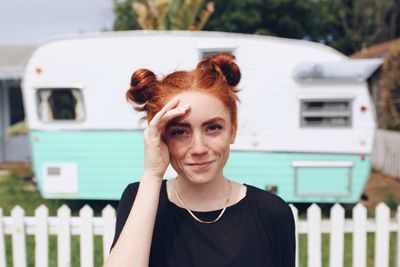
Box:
144 97 189 181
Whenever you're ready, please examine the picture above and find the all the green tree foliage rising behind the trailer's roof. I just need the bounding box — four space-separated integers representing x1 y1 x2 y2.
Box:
114 0 400 54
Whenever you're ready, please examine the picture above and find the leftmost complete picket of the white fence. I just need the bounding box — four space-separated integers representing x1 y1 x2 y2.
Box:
11 206 26 267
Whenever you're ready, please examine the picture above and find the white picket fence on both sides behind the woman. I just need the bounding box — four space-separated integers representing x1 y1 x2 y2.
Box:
0 203 400 267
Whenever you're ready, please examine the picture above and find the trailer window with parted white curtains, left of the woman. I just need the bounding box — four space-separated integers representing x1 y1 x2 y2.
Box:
37 88 85 122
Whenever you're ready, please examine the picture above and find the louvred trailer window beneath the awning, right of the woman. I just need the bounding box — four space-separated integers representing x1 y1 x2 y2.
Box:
300 99 352 128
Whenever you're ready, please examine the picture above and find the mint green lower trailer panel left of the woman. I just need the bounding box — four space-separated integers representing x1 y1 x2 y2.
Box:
31 131 143 199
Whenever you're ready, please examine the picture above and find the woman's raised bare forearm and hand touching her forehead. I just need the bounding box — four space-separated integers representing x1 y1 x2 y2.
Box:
104 98 189 267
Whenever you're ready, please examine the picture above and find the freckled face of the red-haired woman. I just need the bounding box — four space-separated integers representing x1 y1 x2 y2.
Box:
164 92 235 183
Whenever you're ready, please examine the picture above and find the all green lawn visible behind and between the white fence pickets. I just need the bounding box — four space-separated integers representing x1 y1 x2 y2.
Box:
0 170 397 267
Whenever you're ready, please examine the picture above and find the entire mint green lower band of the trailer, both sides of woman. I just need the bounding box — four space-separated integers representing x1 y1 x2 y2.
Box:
31 131 370 203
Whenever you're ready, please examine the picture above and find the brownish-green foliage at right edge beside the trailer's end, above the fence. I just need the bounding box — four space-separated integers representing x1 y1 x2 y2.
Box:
379 46 400 130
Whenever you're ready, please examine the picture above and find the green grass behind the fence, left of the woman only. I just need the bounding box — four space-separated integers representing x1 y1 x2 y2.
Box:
0 170 117 266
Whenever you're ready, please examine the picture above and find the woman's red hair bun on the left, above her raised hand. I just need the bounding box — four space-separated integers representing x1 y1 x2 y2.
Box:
126 69 157 104
